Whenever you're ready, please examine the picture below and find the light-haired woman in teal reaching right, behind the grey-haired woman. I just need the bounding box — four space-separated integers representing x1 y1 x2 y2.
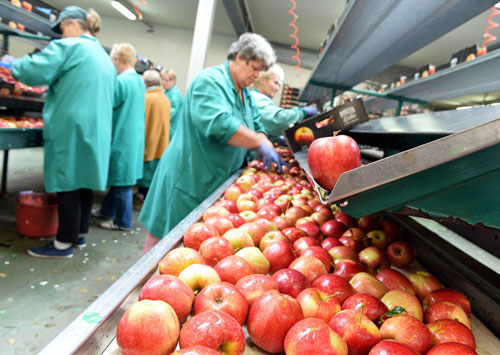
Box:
251 64 318 141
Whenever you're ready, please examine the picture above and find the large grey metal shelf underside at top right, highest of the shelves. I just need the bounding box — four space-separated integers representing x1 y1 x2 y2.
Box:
299 0 496 101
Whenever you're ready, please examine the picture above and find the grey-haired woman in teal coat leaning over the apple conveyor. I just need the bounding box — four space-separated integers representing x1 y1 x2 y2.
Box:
139 33 284 252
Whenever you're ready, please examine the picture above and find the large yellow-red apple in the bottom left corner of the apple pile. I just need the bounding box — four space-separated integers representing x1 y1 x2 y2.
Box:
116 300 179 355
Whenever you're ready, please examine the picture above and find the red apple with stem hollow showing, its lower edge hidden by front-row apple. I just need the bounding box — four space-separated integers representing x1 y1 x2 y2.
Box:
193 282 248 325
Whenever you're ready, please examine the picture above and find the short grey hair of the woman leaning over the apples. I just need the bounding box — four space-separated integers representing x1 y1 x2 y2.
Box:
227 32 276 70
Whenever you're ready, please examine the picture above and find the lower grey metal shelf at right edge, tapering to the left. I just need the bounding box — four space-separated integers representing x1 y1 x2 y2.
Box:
364 50 500 112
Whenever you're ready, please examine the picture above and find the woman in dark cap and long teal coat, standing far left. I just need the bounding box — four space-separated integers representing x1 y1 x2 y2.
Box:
12 6 116 258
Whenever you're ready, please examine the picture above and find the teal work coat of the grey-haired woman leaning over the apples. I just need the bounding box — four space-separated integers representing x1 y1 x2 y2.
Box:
139 61 266 238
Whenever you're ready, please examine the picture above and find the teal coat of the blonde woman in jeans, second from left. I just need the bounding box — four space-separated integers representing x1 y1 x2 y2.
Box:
108 68 146 186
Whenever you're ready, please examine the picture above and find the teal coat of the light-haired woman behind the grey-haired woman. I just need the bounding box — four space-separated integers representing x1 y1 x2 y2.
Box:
251 89 306 140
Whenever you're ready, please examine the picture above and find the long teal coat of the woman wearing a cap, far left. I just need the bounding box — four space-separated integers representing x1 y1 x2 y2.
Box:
12 35 116 192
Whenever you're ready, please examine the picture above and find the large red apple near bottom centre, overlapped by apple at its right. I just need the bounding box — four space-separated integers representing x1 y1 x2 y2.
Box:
247 290 304 353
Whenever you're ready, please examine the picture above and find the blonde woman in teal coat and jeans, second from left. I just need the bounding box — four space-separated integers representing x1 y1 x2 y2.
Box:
92 43 146 230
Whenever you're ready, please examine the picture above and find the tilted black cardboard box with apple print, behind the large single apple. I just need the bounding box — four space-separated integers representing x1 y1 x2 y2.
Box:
283 99 368 152
